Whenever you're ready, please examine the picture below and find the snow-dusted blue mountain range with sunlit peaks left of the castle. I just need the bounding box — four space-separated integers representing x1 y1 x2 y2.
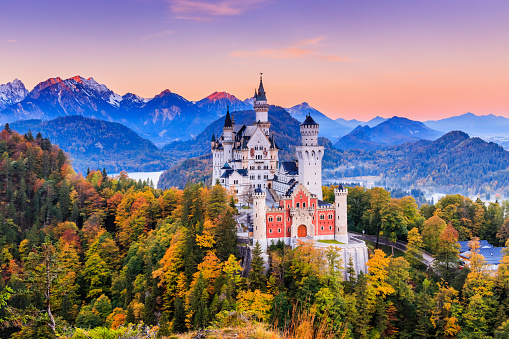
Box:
0 76 216 144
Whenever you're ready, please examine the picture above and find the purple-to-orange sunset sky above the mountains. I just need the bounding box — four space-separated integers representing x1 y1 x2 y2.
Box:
0 0 509 121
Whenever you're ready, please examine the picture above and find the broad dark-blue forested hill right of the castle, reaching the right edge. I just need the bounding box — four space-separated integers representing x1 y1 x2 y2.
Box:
332 131 509 196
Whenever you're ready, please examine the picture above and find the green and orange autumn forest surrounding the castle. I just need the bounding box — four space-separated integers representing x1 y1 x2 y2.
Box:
0 126 509 338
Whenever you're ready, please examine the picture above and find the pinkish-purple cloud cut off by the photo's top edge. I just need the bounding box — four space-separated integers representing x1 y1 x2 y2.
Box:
168 0 267 21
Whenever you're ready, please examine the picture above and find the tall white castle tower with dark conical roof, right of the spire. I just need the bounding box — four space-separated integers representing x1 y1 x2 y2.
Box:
295 115 323 200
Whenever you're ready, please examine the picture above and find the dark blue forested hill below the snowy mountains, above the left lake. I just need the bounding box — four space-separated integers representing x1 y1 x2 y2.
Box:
10 116 176 173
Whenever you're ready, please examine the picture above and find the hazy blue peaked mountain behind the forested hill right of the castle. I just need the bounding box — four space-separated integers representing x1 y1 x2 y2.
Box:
334 117 443 150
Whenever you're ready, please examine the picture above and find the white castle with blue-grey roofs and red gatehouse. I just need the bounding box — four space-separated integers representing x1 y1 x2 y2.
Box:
211 76 368 272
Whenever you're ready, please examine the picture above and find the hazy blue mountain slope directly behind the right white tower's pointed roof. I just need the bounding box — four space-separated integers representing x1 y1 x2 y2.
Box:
286 102 352 140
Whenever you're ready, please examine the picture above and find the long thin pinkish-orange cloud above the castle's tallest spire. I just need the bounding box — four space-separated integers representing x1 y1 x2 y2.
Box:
230 36 354 62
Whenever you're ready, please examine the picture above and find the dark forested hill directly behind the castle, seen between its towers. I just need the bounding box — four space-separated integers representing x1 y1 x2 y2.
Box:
163 106 300 160
